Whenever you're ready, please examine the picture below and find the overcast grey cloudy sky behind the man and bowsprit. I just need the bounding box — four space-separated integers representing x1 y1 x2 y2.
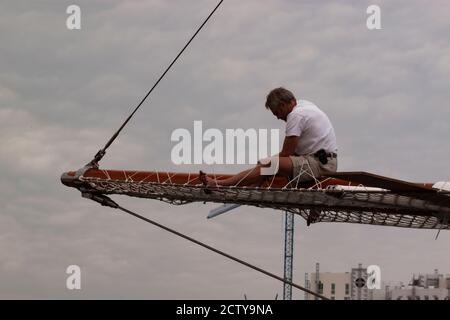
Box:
0 0 450 299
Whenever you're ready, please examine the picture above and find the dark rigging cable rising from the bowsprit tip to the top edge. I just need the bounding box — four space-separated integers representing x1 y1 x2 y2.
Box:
89 0 224 167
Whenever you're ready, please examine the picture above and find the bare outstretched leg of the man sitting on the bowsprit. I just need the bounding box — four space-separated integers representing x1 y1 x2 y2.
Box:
199 157 292 187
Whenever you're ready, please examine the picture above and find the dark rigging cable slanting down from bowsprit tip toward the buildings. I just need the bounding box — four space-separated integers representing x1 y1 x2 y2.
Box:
83 193 329 300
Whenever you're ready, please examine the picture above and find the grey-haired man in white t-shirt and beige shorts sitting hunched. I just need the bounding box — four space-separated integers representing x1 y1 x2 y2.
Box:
200 88 337 186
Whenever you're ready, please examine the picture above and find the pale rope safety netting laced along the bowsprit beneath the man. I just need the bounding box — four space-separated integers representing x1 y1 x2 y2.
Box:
67 162 450 229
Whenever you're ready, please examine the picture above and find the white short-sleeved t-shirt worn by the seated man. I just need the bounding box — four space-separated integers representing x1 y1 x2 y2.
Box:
286 100 337 155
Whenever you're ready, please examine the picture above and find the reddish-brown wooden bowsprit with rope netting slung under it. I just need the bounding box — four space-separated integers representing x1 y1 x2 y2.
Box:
61 168 450 229
